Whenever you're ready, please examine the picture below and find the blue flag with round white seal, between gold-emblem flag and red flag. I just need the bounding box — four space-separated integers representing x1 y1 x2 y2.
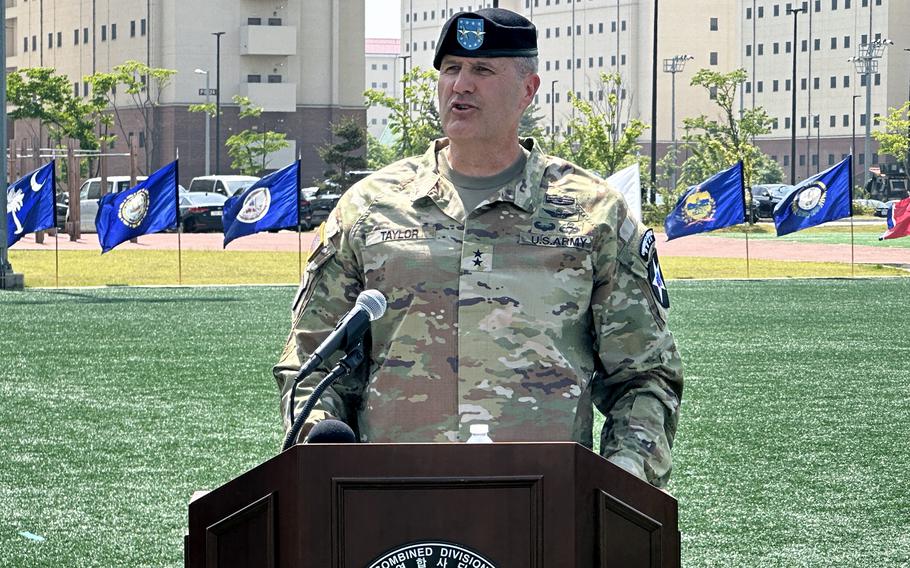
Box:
774 156 853 237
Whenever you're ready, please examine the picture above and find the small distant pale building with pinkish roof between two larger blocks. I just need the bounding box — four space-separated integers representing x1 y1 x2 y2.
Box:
365 38 405 143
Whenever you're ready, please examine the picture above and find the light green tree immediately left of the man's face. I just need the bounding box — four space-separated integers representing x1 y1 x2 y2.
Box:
364 67 443 159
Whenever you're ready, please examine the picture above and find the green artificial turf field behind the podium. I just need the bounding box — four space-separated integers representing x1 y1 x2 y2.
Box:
0 278 910 568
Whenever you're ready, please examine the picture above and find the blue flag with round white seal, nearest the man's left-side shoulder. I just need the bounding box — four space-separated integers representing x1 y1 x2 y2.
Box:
222 160 300 247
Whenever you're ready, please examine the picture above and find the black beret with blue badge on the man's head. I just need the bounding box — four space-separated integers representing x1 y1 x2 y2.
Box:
433 8 537 69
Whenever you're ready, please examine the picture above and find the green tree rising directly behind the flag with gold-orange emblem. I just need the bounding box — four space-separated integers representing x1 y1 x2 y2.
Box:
680 69 782 191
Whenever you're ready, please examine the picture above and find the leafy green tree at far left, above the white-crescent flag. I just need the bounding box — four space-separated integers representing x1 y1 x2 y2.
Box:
6 67 113 150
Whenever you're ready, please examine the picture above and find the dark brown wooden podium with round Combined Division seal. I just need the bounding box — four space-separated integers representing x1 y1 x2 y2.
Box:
186 442 680 568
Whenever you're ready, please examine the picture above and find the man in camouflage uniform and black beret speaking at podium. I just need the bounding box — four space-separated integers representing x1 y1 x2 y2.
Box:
274 8 682 486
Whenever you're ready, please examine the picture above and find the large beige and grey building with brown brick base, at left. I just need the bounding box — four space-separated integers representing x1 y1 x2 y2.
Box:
6 0 366 184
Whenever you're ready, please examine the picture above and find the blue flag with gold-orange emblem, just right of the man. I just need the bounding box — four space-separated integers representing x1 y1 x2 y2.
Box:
664 162 746 241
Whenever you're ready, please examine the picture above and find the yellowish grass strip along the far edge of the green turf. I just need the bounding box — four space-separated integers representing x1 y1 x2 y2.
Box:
10 247 910 287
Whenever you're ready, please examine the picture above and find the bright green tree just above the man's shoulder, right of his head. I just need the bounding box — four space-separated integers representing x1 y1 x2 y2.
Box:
553 73 648 177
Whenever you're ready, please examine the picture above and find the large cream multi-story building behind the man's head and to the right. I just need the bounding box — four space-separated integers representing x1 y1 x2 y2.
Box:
401 0 910 184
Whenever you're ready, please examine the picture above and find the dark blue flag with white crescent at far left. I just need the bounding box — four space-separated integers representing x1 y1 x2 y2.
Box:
6 160 57 247
